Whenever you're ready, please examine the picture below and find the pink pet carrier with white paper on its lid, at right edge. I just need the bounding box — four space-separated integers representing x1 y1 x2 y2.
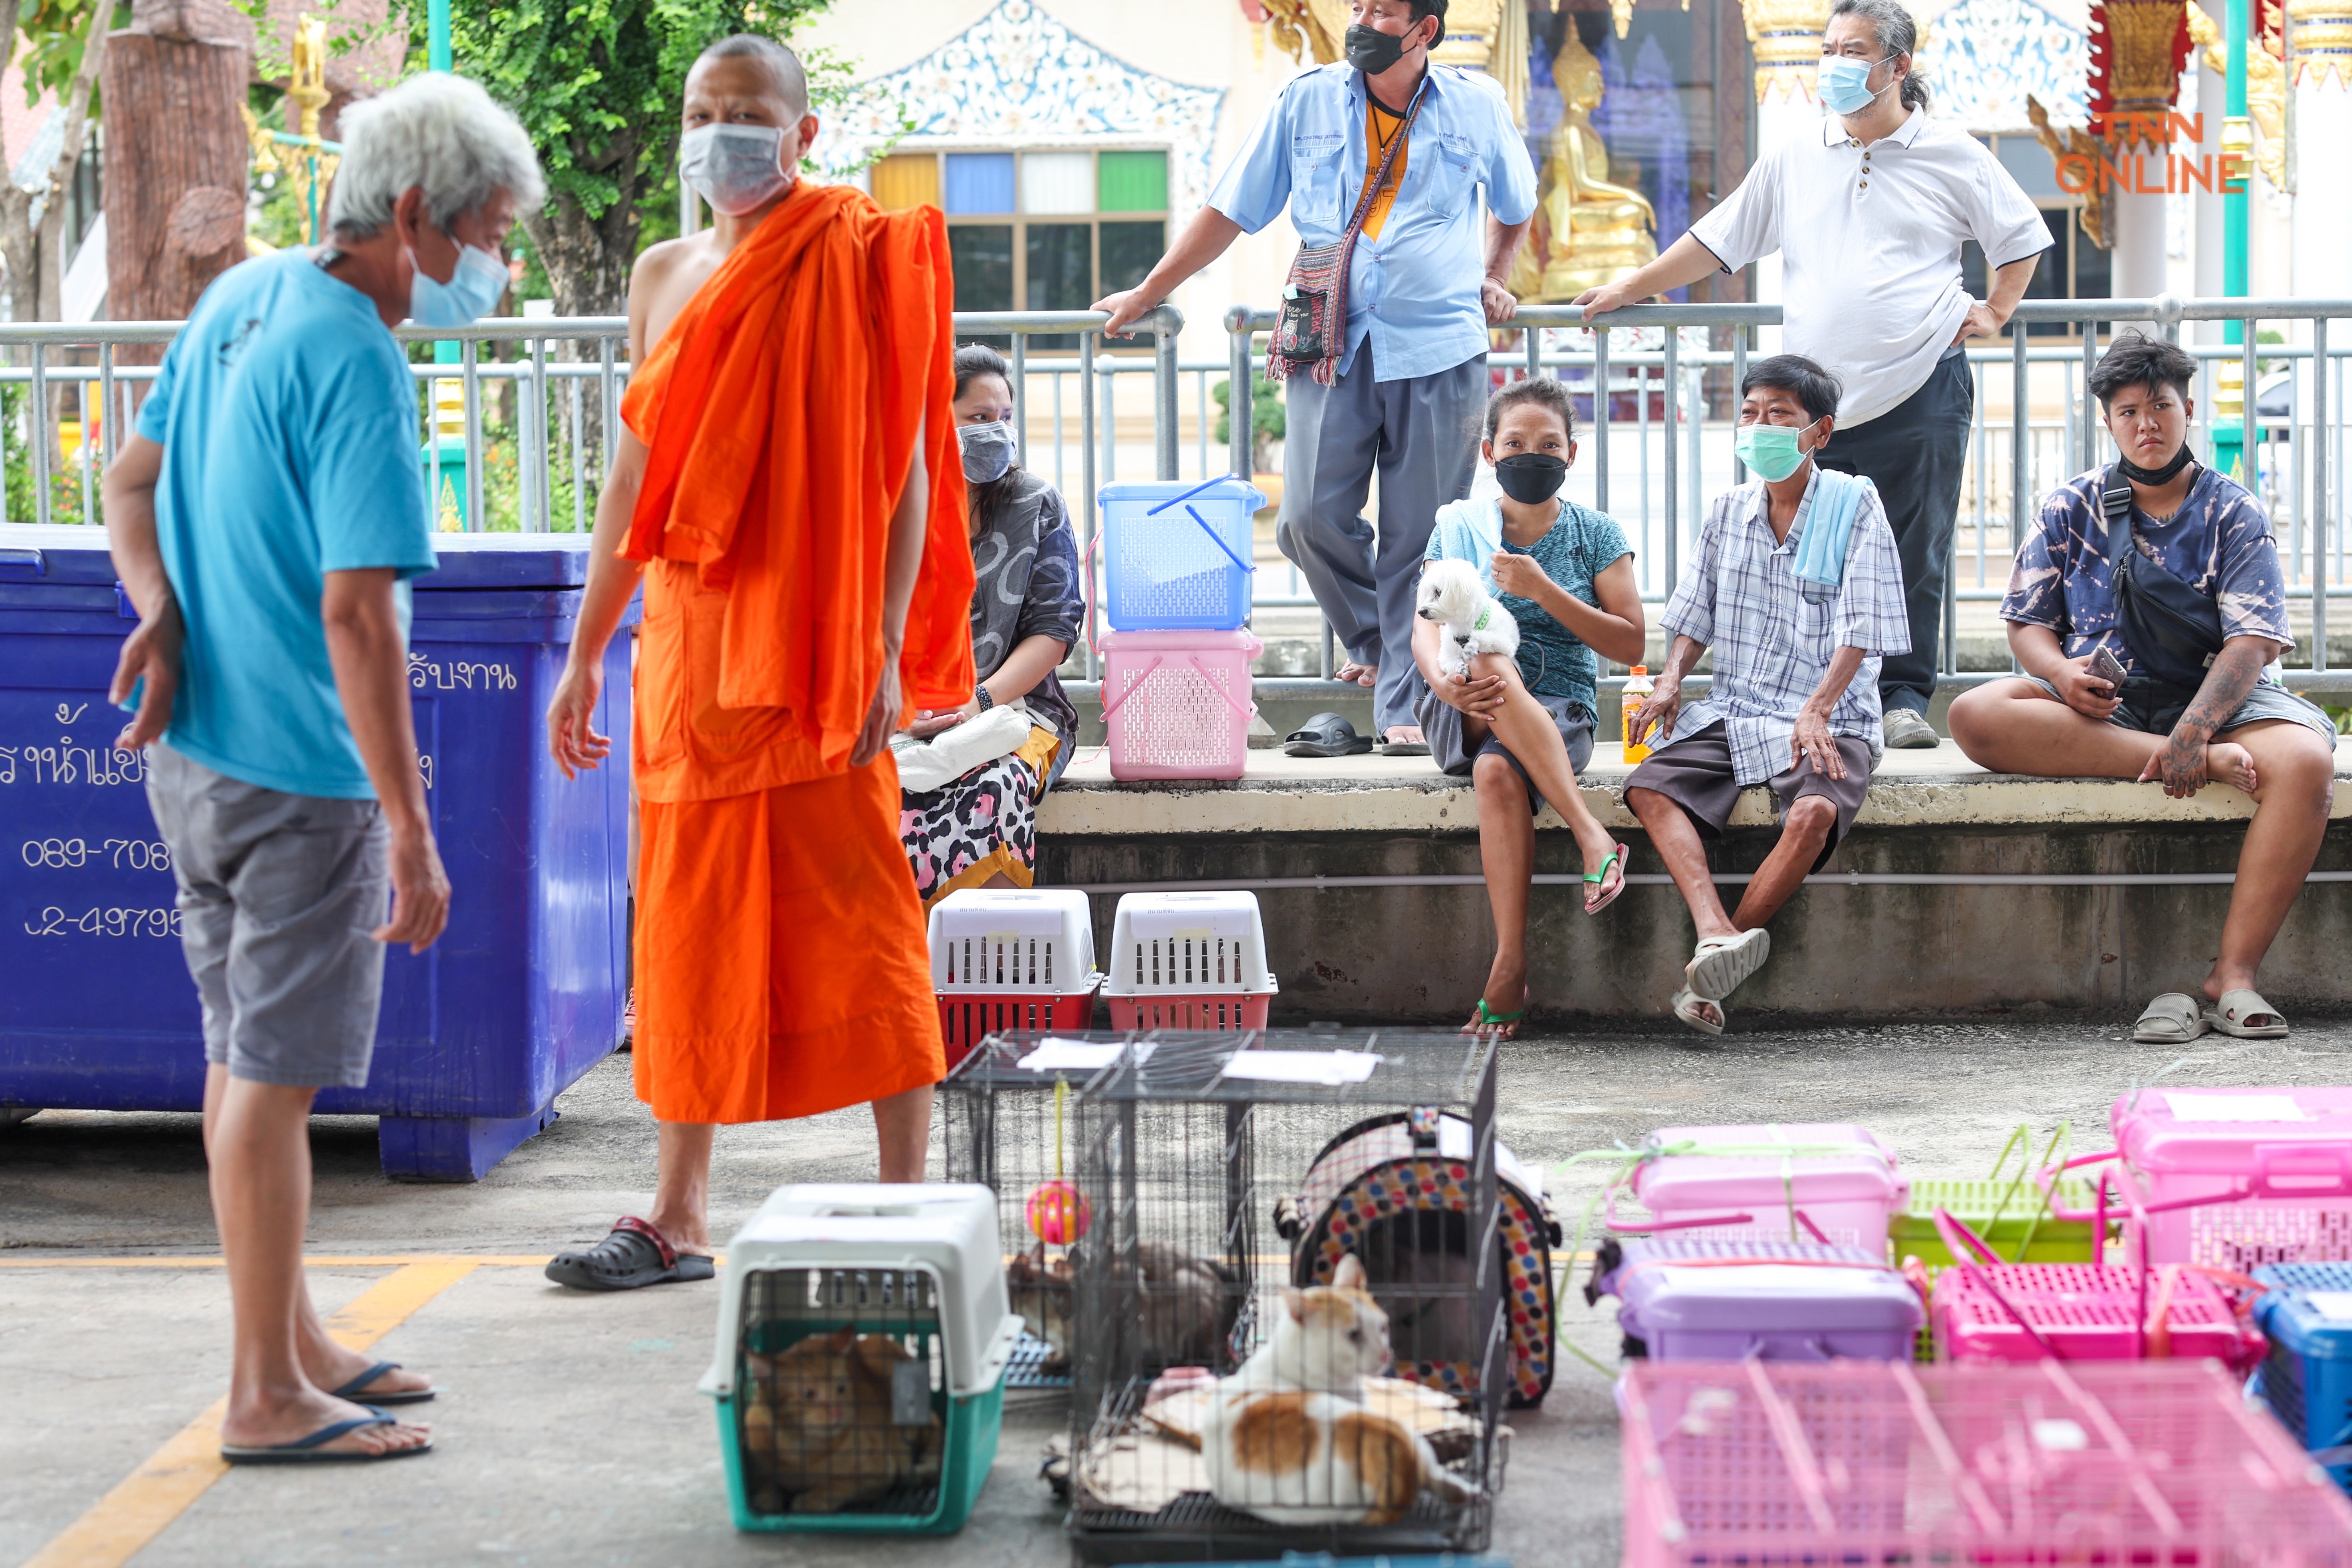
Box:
2065 1088 2352 1274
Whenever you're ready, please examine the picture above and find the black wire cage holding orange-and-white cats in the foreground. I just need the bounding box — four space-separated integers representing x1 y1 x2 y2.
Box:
1066 1032 1512 1563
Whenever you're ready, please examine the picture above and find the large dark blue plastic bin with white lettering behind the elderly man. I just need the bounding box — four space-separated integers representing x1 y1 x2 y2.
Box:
0 524 635 1180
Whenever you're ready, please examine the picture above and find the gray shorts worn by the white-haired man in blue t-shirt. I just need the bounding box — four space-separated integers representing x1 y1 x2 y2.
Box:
146 745 391 1088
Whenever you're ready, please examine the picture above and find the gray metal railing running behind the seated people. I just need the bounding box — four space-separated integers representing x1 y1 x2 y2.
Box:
0 296 2352 677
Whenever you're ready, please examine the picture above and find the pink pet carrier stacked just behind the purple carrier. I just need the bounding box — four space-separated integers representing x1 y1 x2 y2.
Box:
1606 1121 1910 1256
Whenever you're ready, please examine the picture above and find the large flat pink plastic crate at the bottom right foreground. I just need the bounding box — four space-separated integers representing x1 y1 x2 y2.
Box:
1618 1361 2352 1568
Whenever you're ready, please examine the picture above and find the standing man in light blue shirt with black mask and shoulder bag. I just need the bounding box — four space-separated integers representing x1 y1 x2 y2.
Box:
1096 0 1536 752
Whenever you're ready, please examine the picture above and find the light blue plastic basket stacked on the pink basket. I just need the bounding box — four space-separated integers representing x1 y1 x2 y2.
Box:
1096 475 1266 633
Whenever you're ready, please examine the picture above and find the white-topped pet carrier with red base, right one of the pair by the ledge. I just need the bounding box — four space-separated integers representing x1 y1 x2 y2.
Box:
1103 893 1277 1030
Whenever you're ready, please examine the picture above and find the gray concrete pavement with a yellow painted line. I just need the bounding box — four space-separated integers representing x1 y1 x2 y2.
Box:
0 1013 2352 1568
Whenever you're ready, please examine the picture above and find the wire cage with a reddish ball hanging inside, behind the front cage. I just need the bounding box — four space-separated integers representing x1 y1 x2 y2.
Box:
939 1032 1134 1389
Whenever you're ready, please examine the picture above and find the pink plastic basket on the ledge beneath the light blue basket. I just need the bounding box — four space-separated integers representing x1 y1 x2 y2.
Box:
1101 633 1266 778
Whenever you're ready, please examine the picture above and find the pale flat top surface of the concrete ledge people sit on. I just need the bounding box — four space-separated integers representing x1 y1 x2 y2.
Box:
1037 738 2352 837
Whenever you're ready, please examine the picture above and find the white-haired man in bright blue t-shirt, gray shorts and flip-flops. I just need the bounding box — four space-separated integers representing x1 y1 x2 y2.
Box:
106 73 541 1465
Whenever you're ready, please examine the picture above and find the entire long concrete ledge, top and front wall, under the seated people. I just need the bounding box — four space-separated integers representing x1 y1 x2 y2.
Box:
1037 743 2352 1030
